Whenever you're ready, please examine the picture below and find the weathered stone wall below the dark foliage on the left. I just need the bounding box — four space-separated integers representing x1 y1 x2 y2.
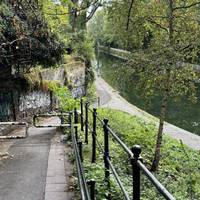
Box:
0 61 85 135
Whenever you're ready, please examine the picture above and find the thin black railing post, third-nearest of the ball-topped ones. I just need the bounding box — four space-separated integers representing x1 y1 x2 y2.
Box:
92 108 97 163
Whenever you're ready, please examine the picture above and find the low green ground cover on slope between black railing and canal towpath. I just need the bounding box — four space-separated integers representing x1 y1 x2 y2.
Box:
84 109 200 200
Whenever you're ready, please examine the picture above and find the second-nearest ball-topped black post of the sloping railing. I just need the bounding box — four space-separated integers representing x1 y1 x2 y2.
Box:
103 119 110 199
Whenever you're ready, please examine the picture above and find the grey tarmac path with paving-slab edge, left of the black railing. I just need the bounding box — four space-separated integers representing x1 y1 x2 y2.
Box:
0 118 72 200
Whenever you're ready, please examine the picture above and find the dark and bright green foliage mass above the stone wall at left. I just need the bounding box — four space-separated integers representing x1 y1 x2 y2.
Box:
0 0 100 84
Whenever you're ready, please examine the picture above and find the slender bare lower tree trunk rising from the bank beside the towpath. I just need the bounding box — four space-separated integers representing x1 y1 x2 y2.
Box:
151 90 168 171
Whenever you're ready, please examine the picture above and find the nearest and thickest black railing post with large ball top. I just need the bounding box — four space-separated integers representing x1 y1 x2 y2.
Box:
131 145 142 200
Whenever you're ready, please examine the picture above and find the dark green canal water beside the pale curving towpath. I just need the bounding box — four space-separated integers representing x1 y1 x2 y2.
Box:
97 53 200 135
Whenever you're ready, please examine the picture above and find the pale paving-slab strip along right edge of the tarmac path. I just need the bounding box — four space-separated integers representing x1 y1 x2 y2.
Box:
45 134 74 200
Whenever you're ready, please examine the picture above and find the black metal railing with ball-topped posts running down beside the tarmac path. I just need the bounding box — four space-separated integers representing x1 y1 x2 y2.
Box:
71 99 175 200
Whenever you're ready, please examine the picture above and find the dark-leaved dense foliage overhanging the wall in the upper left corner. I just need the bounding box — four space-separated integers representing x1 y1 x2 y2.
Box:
0 0 64 74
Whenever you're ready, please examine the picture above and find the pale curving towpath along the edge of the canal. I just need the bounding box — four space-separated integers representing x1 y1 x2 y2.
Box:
95 77 200 150
